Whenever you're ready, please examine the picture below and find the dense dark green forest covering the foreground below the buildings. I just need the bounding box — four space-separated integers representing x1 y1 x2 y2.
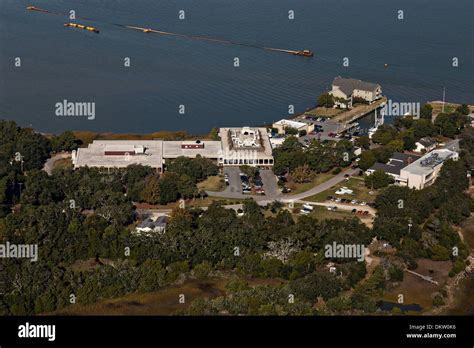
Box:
0 121 474 315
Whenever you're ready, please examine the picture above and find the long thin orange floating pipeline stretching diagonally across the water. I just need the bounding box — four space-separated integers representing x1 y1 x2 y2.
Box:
26 6 313 57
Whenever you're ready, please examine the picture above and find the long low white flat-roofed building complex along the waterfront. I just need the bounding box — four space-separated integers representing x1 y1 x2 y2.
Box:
72 127 273 172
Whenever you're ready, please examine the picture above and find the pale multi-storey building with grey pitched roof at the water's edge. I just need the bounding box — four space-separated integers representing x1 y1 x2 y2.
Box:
329 76 382 109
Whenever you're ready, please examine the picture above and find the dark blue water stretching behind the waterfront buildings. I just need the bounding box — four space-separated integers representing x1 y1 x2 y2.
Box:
0 0 474 133
